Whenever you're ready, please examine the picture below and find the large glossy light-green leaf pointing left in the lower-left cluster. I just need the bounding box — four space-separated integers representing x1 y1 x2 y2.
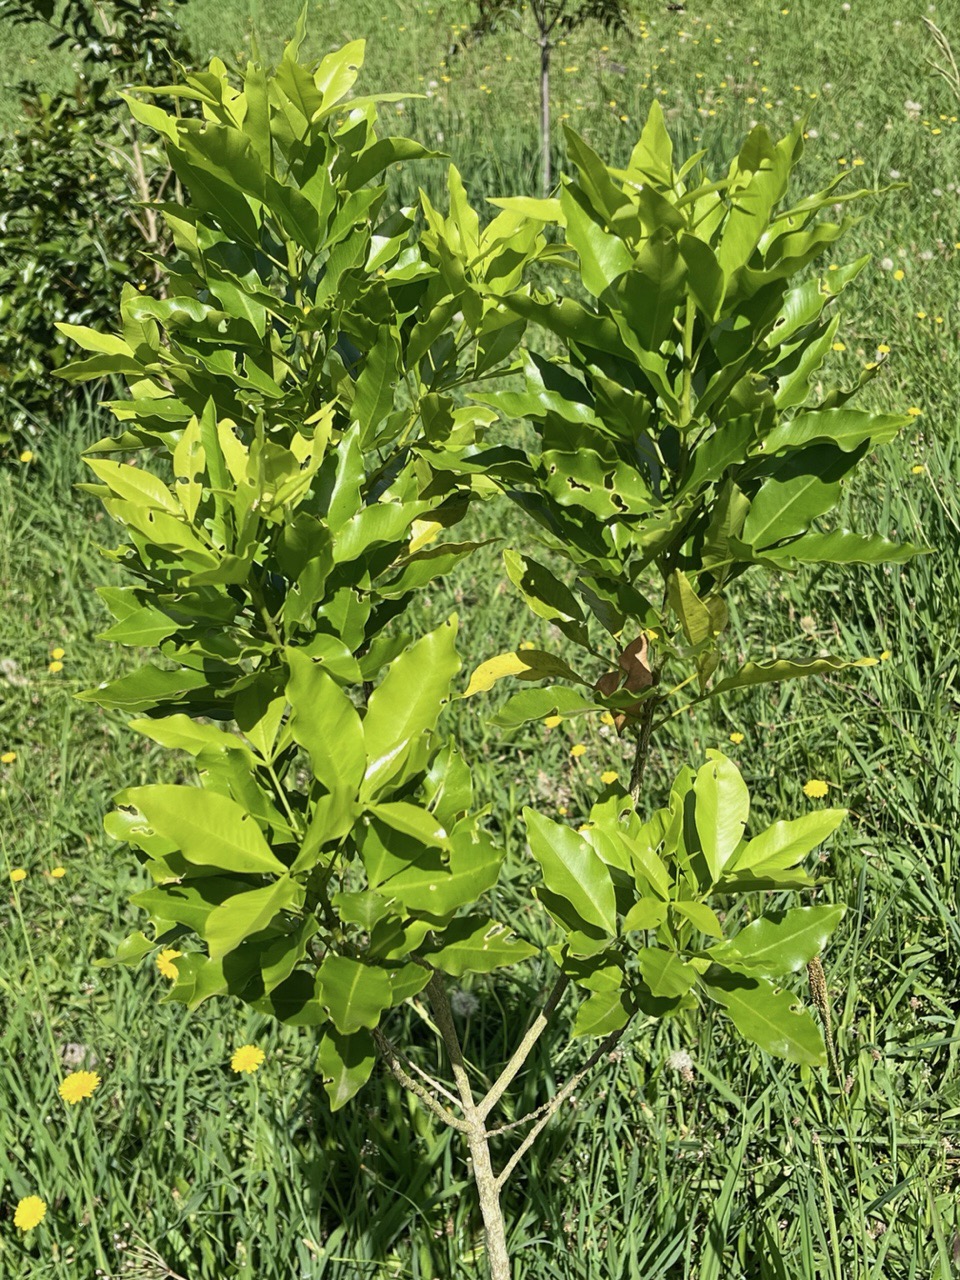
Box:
118 785 287 876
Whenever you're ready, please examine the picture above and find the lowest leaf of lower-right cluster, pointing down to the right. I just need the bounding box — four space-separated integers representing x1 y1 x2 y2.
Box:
703 969 827 1066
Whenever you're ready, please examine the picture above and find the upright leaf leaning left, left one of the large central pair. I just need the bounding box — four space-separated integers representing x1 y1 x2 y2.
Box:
284 648 366 795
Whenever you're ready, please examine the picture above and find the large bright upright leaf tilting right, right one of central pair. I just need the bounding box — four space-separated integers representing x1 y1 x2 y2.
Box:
364 616 460 796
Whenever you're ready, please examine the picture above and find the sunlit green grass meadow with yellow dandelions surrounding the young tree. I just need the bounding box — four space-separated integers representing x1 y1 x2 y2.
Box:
0 0 960 1280
